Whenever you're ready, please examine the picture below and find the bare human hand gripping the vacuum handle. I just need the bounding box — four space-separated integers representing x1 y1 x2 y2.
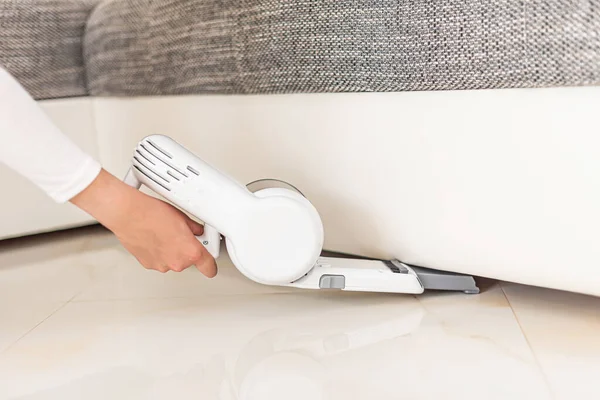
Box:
71 170 217 278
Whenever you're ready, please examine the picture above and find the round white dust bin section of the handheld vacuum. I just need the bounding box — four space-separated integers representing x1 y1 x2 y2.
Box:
220 179 324 285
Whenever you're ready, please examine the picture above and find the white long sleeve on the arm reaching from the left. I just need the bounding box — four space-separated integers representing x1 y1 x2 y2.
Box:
0 67 101 203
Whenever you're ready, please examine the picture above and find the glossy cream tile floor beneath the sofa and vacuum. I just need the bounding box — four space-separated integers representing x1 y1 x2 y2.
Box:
0 228 600 400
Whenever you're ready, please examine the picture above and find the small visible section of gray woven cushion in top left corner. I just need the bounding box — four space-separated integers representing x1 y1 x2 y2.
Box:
0 0 94 99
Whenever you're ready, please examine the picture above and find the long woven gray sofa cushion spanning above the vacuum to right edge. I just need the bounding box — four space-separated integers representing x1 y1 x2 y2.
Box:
85 0 600 95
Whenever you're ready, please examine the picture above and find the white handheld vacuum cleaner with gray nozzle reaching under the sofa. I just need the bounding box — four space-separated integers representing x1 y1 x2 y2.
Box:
125 135 479 294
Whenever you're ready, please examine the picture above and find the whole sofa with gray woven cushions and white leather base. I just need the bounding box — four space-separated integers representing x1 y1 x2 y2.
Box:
0 0 600 295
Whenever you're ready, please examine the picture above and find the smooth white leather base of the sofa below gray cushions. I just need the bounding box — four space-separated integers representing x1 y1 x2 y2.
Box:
0 87 600 295
